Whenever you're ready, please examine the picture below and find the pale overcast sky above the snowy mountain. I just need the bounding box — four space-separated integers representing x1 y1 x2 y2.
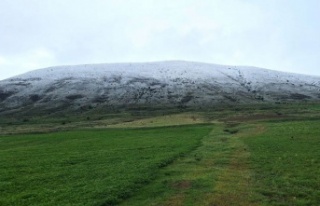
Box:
0 0 320 79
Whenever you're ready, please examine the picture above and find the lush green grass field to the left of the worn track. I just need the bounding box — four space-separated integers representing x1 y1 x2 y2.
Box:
0 125 211 205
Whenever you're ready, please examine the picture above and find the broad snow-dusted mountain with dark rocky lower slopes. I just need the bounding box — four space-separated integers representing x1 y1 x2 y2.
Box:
0 61 320 113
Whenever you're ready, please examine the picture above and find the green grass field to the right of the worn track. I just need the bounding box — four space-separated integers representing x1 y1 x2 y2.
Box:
245 121 320 205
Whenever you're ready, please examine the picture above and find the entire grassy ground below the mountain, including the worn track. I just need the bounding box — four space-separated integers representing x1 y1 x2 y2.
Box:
0 105 320 206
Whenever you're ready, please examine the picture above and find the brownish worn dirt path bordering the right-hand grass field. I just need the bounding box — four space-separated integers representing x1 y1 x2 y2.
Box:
208 125 265 206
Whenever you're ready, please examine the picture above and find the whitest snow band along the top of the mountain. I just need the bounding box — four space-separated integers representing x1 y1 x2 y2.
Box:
11 61 319 81
